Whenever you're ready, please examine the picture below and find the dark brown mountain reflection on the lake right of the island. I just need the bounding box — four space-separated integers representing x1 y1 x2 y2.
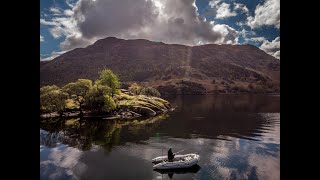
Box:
159 95 280 139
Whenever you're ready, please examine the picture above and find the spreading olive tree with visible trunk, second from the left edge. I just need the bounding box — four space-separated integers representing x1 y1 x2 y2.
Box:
63 79 92 113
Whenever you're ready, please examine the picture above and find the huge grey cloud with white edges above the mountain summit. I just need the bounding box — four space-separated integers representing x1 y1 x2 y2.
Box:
42 0 238 51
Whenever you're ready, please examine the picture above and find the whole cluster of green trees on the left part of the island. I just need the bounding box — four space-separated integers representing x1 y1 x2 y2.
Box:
40 69 120 115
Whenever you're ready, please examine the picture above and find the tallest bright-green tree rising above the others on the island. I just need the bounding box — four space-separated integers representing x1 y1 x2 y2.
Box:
96 69 120 97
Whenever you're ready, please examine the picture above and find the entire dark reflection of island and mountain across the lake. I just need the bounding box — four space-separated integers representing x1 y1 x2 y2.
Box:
40 95 280 151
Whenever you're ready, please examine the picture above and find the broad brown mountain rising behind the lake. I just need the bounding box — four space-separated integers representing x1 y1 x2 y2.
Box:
40 37 280 94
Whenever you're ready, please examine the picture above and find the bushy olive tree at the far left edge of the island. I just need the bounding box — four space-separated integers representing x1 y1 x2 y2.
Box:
40 86 68 116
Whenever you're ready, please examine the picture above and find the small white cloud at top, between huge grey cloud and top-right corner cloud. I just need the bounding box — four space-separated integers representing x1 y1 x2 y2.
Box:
209 0 237 19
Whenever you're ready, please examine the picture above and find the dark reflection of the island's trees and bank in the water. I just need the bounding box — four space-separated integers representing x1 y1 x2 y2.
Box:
40 114 168 153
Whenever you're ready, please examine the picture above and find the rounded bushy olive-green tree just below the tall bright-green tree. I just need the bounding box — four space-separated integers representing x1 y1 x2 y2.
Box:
85 84 116 112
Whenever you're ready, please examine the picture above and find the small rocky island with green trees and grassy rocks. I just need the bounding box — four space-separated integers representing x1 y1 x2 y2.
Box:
40 69 172 119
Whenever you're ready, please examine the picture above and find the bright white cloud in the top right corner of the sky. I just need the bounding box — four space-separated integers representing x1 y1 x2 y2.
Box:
247 0 280 29
